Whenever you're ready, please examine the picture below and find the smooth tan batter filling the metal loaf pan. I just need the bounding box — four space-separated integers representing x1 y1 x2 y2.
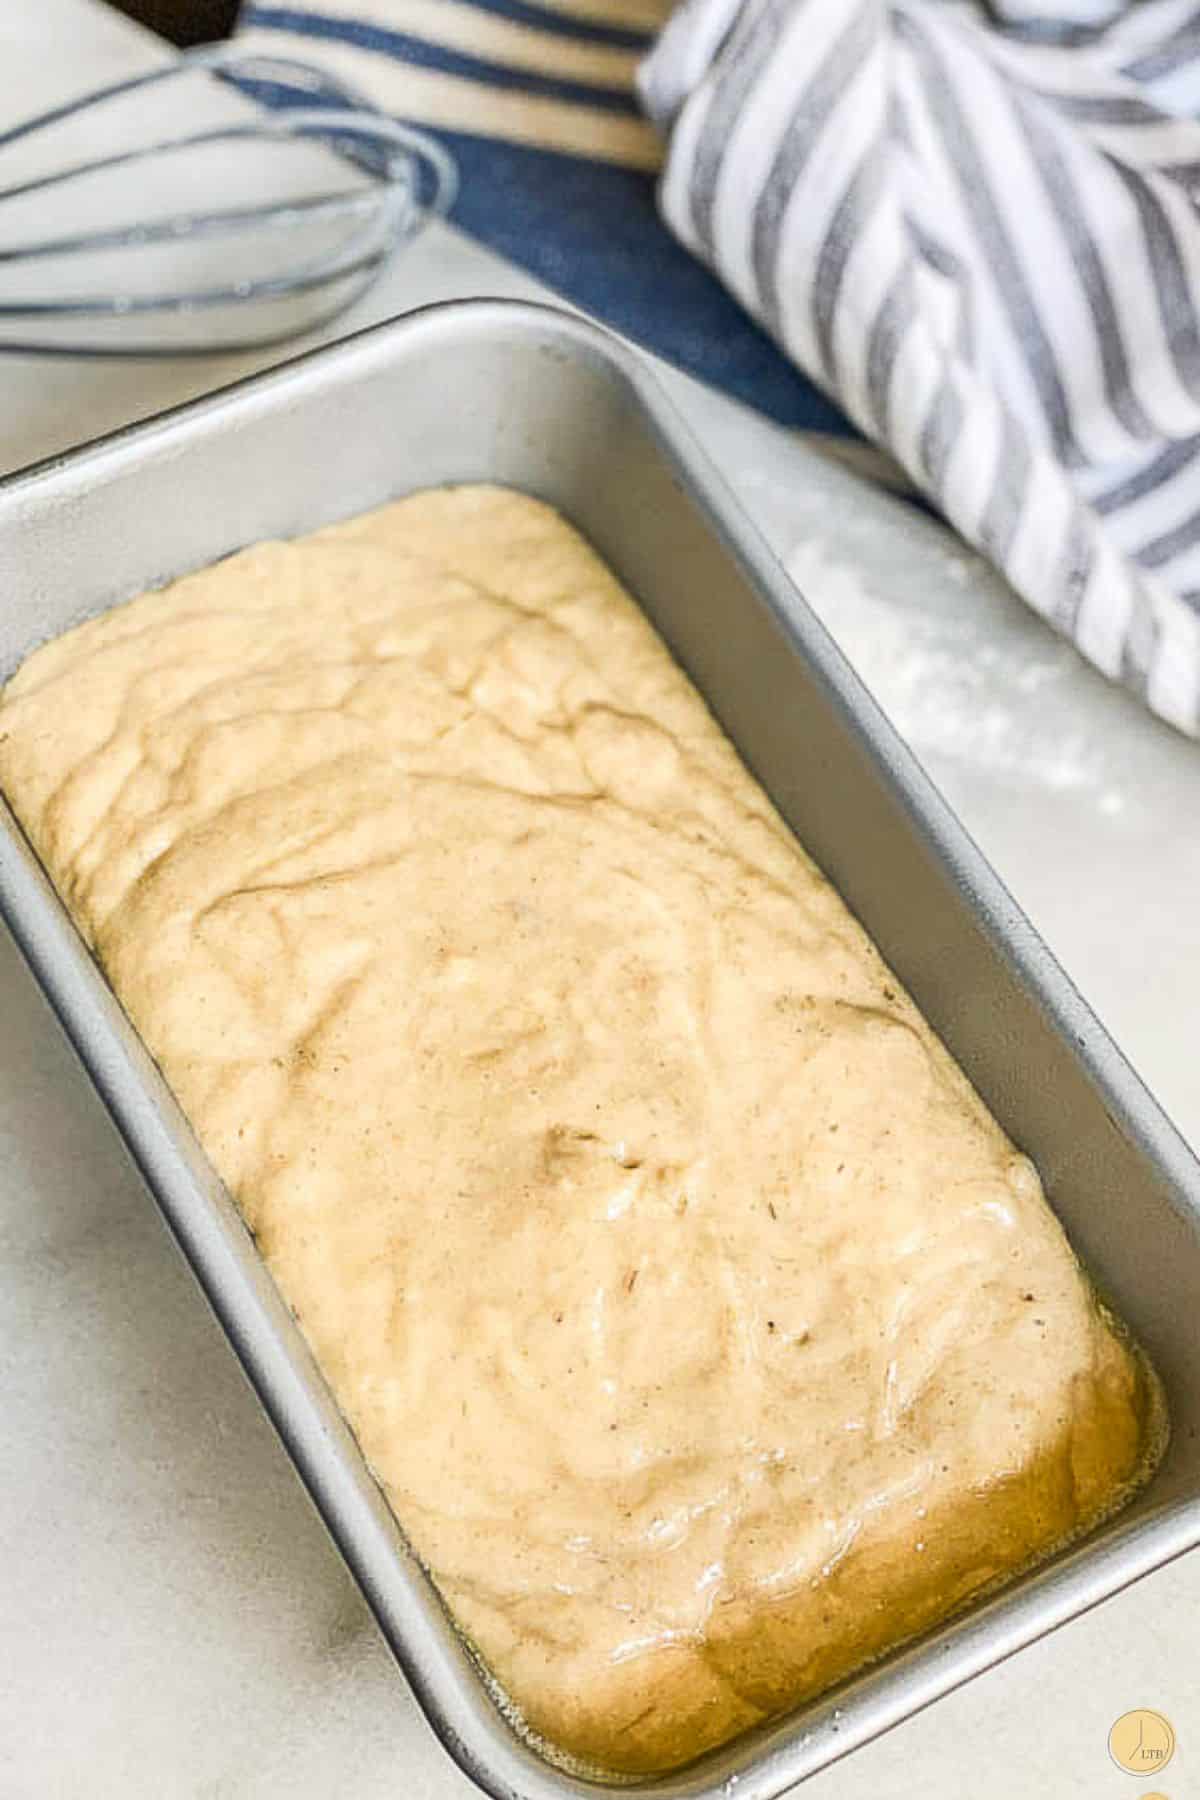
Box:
0 488 1153 1771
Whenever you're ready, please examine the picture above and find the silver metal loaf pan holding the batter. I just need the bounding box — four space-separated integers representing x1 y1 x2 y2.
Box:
0 302 1200 1800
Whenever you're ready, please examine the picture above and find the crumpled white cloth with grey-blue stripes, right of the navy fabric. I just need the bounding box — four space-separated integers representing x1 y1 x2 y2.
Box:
640 0 1200 734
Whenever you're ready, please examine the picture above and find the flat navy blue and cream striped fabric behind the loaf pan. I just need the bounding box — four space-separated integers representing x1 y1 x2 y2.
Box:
237 0 867 450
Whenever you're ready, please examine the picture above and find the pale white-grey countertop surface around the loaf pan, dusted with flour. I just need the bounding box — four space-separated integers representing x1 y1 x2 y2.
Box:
0 0 1200 1800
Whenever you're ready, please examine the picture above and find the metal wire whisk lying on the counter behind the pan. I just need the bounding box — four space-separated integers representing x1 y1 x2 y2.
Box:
0 45 457 356
